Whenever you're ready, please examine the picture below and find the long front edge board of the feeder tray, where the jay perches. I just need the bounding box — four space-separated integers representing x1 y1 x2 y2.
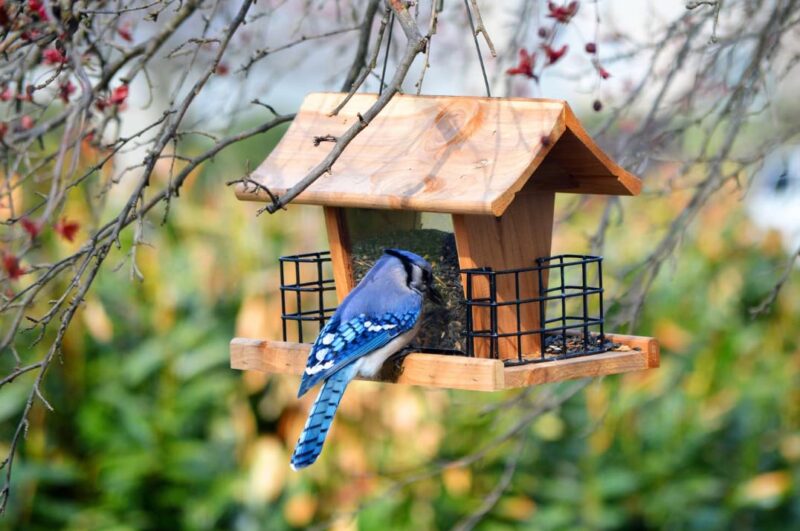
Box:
230 338 503 391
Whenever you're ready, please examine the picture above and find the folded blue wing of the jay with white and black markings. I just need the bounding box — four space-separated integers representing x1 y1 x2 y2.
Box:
297 307 421 398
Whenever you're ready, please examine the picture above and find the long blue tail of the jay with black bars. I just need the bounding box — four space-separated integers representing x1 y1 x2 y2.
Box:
292 364 356 470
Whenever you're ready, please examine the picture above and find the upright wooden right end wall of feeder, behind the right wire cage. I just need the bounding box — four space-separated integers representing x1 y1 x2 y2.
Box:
453 183 555 359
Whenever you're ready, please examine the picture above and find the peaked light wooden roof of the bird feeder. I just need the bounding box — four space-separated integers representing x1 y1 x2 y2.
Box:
236 93 641 216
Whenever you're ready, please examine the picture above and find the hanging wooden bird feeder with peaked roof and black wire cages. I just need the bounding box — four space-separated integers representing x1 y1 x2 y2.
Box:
231 93 659 391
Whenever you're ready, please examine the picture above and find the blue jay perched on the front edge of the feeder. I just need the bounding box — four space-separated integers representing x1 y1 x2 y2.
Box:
291 249 441 470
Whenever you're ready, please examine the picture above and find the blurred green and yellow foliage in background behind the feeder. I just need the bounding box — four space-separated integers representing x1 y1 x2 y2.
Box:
0 130 800 530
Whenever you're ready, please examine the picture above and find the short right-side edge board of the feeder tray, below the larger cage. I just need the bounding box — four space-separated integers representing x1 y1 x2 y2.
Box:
504 335 660 389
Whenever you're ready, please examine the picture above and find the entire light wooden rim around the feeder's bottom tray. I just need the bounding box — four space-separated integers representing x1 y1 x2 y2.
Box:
230 335 659 391
